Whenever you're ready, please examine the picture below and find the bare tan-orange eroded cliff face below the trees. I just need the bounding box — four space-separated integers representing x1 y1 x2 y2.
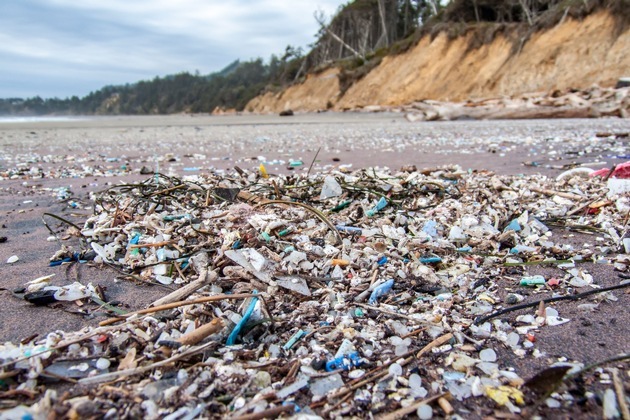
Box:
246 12 630 113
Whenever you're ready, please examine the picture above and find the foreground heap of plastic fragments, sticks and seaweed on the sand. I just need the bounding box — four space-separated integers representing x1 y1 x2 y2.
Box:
0 166 630 419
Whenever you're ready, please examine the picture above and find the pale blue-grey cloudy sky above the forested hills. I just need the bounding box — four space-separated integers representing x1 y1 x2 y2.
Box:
0 0 344 98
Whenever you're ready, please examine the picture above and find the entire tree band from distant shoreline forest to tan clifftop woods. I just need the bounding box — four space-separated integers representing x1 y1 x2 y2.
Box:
0 0 630 115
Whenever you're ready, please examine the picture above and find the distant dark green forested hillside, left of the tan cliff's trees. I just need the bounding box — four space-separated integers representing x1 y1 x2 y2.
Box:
0 46 303 115
